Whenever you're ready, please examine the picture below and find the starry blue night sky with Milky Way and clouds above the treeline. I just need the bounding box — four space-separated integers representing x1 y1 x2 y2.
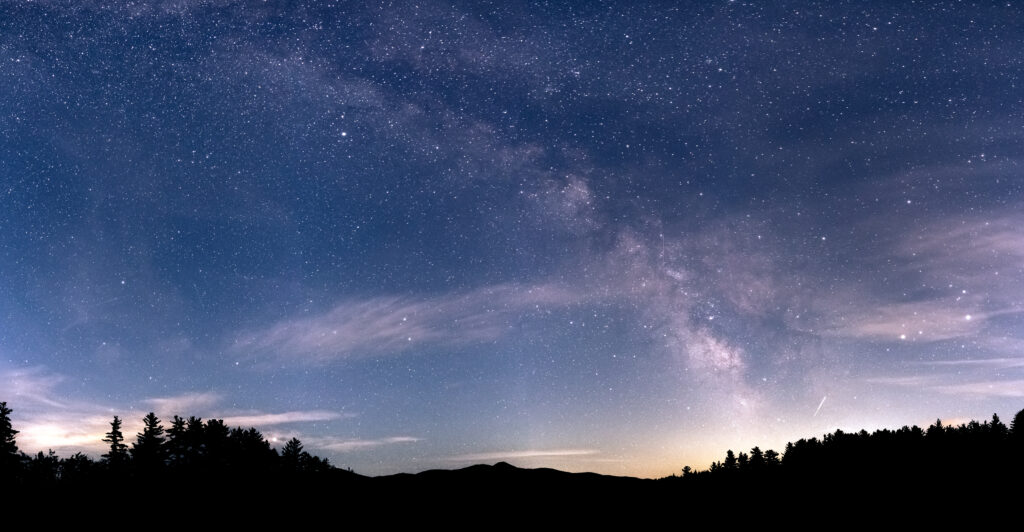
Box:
0 0 1024 477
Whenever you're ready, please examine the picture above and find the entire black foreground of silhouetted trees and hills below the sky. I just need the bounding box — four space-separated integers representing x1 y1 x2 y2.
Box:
0 403 1024 519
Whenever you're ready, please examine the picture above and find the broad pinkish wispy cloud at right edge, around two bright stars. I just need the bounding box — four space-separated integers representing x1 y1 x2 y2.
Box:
790 213 1024 344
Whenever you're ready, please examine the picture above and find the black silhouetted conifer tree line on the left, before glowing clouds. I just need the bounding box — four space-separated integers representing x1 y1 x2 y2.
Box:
0 402 336 487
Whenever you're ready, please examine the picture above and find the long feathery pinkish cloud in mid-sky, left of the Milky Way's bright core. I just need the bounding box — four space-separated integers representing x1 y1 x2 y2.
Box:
233 284 580 362
